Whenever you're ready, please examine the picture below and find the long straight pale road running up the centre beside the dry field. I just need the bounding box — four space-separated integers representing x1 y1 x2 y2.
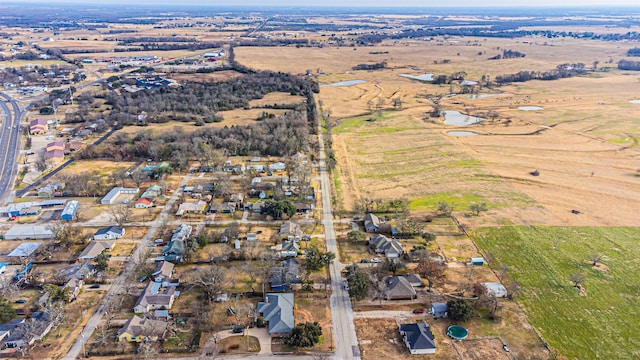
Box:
318 110 360 360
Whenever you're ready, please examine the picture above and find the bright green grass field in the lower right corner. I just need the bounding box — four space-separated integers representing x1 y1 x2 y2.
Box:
474 227 640 359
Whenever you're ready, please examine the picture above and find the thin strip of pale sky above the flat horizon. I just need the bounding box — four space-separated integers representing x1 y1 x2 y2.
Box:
5 0 640 7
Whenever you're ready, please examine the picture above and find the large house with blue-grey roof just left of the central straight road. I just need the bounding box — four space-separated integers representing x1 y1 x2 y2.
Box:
257 293 294 336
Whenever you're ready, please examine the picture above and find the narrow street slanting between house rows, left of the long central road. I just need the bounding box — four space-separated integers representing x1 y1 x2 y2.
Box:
62 176 191 360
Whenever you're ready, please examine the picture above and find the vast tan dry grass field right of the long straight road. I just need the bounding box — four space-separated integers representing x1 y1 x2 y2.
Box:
236 38 640 225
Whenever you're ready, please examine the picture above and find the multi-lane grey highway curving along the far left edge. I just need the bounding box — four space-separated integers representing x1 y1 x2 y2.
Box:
0 92 24 204
